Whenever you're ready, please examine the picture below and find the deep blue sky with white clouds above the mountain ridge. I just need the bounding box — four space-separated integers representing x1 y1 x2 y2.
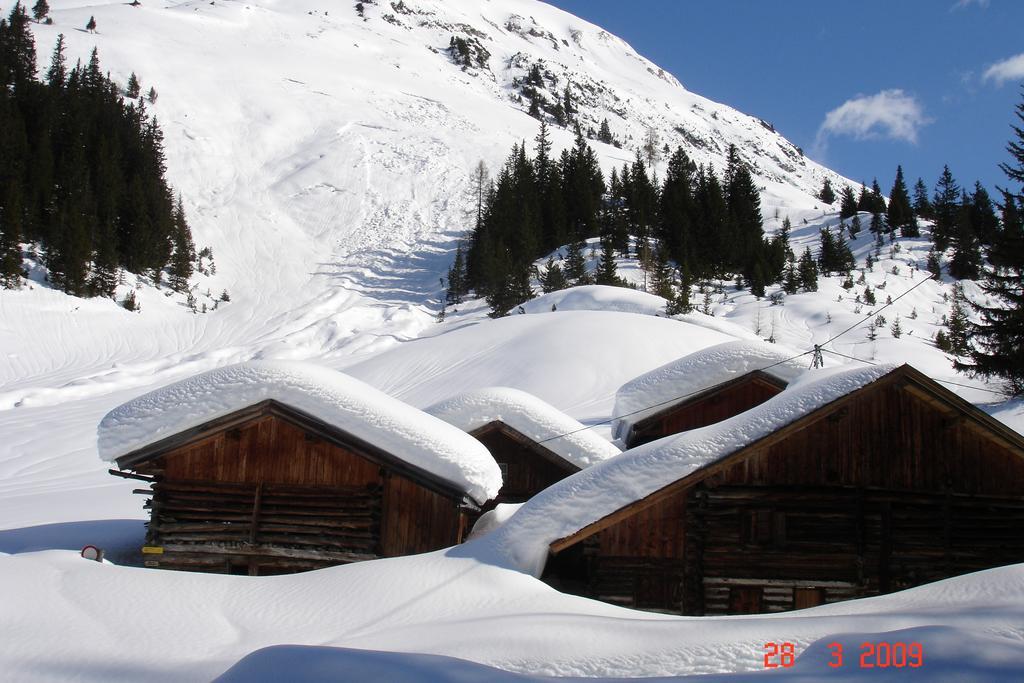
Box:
548 0 1024 198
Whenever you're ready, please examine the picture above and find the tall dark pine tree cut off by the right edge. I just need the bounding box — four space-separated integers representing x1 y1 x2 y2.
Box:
955 90 1024 395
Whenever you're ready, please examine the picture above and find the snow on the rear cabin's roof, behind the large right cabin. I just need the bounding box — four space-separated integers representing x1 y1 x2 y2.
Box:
611 340 808 441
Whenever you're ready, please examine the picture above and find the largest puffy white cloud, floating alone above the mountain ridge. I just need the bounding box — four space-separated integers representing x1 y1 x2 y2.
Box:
814 89 931 153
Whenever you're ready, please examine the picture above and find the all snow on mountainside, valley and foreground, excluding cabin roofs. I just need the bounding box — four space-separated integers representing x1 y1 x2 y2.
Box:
0 0 1024 681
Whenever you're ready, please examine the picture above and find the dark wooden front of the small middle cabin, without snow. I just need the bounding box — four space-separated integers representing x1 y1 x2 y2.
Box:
469 420 580 511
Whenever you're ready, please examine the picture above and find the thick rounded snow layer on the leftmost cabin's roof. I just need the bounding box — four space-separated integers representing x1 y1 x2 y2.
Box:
98 360 502 503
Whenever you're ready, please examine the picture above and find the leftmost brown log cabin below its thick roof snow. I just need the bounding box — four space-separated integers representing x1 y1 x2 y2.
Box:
112 401 491 575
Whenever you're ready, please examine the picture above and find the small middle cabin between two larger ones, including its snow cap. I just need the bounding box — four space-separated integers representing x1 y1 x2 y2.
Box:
426 387 622 511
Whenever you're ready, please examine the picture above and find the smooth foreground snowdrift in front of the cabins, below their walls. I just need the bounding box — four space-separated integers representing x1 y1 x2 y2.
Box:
0 536 1024 681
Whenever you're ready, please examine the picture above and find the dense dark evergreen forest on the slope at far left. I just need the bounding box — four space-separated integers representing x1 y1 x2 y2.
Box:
0 3 196 297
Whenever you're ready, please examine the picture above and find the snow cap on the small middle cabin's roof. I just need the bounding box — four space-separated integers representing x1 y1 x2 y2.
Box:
427 387 621 469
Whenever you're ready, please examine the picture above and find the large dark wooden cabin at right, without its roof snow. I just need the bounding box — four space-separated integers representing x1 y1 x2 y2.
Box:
545 366 1024 614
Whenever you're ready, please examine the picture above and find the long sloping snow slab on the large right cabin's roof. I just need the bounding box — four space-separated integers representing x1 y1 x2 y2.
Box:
492 366 896 574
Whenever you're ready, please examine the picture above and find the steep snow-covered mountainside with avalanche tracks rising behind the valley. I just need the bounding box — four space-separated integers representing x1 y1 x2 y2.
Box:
0 0 840 393
